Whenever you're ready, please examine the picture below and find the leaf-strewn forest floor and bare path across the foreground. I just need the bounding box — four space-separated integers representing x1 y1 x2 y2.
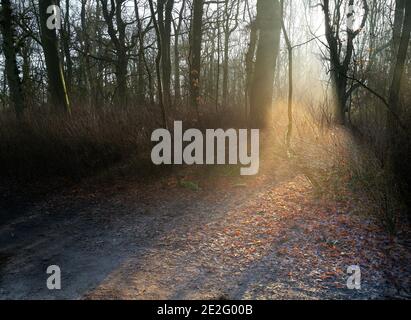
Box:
0 134 411 299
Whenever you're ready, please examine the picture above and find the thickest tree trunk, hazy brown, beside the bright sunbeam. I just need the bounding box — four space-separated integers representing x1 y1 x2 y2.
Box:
250 0 281 128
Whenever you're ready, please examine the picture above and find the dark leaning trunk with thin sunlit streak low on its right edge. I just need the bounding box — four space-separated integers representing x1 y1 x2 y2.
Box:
39 0 70 112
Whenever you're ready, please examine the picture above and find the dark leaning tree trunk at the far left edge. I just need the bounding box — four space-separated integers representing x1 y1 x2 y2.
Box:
0 0 24 118
